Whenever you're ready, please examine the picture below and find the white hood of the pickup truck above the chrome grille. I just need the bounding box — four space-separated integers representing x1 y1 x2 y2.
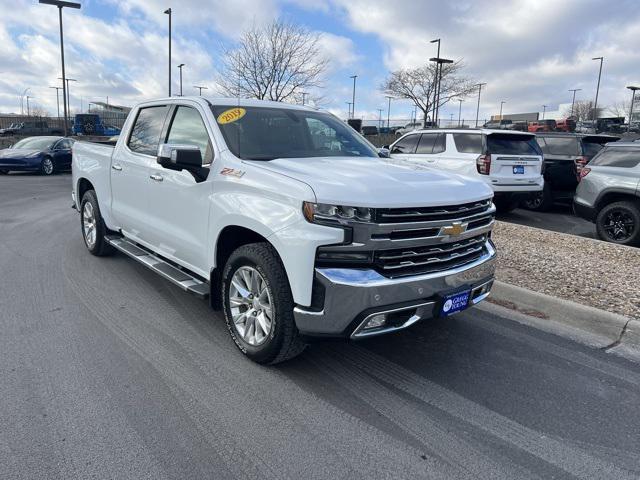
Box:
251 157 493 208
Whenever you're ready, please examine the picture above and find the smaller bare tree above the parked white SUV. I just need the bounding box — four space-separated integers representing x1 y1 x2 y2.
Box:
380 61 476 125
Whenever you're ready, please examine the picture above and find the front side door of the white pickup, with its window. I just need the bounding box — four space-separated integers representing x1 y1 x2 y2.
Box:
145 103 213 276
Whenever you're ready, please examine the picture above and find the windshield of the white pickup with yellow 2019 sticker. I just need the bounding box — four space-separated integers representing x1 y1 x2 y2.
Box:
211 105 378 160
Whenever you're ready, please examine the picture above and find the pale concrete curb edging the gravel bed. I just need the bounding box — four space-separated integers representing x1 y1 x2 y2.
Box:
478 281 640 362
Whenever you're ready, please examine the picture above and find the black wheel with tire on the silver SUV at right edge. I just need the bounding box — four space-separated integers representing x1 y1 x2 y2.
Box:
596 201 640 247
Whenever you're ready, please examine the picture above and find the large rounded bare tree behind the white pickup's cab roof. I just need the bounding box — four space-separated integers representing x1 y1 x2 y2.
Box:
218 21 327 103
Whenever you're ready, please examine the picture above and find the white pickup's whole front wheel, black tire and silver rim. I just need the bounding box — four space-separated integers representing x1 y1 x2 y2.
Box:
221 243 305 364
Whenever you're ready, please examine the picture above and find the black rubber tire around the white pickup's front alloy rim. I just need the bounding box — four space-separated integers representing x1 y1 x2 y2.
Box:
221 243 306 365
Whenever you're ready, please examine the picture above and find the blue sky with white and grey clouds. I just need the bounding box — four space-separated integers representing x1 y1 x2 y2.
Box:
0 0 640 124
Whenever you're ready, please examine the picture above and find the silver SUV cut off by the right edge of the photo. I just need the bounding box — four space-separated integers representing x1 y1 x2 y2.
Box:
573 142 640 246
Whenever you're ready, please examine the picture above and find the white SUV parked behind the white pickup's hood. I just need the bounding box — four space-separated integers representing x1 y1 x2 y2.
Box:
389 129 544 211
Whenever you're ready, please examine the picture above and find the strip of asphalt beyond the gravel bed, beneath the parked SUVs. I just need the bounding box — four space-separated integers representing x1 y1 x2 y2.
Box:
497 204 598 238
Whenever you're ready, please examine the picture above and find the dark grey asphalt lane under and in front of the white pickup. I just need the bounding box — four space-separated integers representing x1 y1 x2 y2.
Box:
0 175 640 479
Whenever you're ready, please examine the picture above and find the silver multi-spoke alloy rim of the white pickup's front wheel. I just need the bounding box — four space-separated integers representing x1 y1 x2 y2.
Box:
229 266 273 346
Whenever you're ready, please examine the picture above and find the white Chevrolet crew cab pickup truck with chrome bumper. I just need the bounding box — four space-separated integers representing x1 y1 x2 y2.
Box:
72 97 496 363
